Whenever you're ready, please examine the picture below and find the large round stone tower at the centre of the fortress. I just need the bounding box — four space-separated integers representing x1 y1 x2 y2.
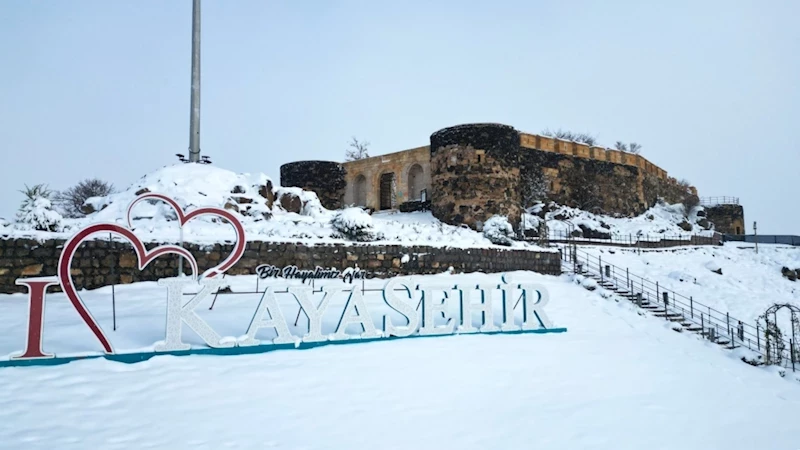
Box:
431 124 521 230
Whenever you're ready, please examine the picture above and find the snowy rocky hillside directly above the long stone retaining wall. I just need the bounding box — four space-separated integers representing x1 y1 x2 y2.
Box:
0 164 531 248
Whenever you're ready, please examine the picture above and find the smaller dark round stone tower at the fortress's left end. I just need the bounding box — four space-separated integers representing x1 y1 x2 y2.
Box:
281 161 346 209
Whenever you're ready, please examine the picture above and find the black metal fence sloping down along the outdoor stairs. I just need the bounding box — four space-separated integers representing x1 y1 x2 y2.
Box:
561 246 800 370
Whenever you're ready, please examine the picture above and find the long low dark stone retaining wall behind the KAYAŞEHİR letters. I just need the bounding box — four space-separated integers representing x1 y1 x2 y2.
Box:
0 239 561 293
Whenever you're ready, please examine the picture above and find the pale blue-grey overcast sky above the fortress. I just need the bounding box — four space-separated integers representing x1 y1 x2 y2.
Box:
0 0 800 234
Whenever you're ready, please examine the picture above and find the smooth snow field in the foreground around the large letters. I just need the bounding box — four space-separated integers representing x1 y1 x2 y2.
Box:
0 272 800 450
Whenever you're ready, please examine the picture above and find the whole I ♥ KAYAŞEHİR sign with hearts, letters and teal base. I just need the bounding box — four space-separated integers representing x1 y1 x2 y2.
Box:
6 193 566 367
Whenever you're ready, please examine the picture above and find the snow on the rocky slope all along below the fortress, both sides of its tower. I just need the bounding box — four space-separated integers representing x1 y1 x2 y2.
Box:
0 164 702 248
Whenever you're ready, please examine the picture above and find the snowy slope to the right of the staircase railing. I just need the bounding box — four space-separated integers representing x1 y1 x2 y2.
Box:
581 242 800 330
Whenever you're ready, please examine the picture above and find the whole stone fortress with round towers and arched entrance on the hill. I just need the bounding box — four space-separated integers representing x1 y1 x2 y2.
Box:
280 123 744 234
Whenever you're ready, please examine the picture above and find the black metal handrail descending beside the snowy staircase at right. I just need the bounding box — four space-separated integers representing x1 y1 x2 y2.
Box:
562 248 794 367
